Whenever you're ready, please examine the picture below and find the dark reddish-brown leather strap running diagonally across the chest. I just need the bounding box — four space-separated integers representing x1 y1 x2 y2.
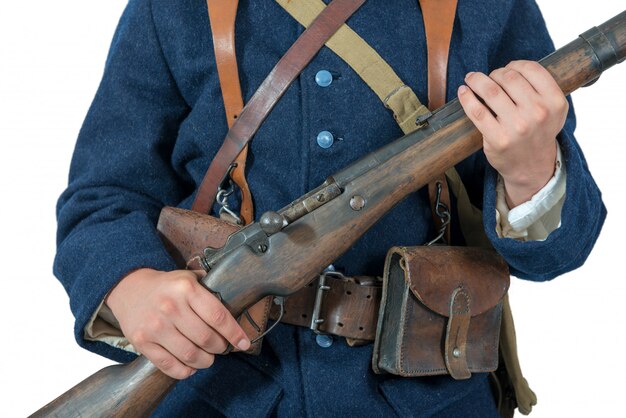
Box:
192 0 365 213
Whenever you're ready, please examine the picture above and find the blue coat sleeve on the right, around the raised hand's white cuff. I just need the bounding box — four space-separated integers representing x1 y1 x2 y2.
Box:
483 0 606 281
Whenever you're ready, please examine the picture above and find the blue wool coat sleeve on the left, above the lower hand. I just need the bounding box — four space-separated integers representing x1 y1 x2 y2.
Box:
54 0 193 361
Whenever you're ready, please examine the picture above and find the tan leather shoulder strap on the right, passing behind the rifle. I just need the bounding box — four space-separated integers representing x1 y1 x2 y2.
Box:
419 0 457 243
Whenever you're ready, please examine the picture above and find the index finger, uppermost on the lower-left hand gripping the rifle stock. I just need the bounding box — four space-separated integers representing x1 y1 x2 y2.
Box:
189 285 250 351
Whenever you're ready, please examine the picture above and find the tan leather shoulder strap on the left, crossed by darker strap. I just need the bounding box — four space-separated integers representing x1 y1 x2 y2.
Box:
207 0 254 225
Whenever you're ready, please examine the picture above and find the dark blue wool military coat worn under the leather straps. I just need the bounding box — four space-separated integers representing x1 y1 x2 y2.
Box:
54 0 605 417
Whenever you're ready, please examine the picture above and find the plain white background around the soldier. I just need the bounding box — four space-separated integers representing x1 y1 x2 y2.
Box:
0 0 626 418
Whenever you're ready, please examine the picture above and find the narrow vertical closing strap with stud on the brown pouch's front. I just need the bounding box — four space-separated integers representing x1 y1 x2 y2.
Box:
444 287 472 380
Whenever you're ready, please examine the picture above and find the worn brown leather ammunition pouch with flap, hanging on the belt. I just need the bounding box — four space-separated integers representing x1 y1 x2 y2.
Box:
372 246 509 379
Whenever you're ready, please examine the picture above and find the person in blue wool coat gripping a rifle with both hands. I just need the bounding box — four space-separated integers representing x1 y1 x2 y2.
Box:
55 0 605 417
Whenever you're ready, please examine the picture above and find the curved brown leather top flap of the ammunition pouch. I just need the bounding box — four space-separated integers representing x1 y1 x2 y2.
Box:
390 245 509 317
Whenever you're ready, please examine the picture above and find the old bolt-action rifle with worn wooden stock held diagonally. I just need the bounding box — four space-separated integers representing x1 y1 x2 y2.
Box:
32 12 626 417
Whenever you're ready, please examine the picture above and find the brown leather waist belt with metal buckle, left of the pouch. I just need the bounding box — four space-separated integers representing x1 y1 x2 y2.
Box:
270 271 382 345
